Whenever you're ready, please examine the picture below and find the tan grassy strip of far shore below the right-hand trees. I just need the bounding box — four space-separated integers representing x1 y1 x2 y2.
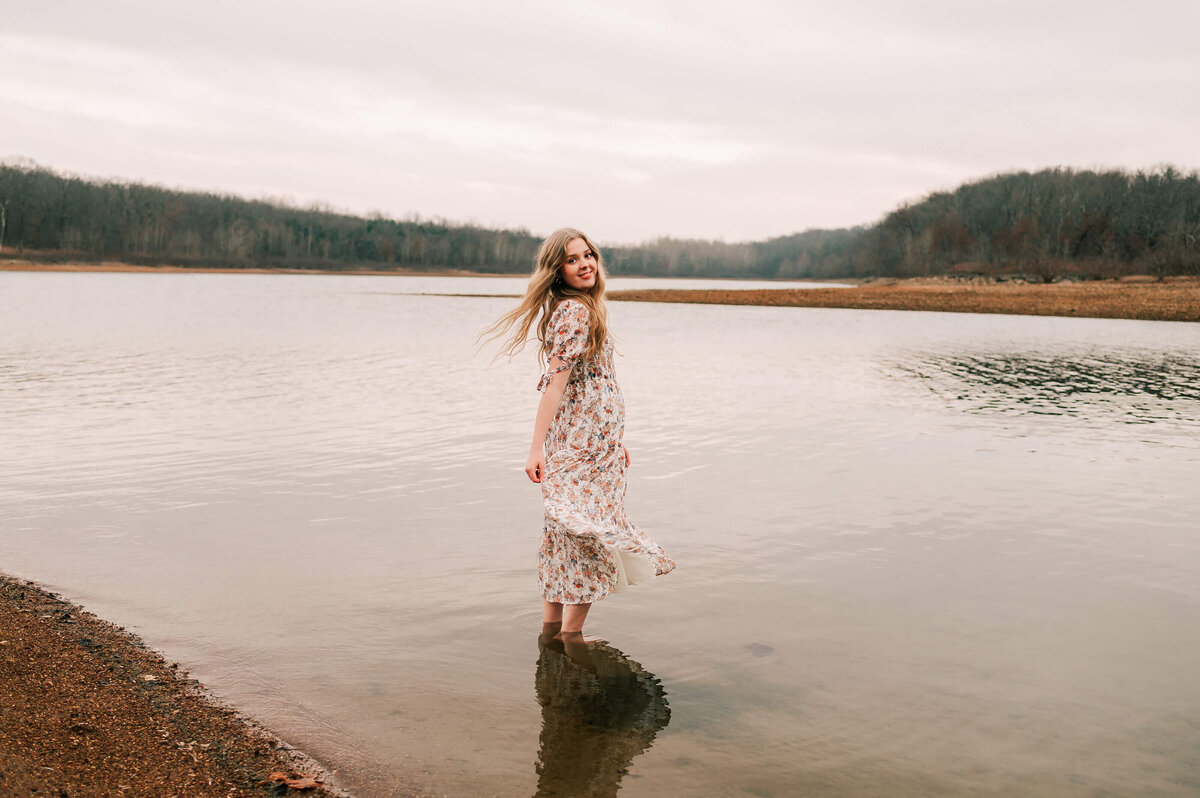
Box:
608 278 1200 322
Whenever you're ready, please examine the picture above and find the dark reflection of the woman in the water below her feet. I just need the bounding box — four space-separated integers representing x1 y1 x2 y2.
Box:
536 631 671 798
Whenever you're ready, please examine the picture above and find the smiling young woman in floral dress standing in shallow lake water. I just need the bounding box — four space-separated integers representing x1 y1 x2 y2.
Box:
485 228 674 638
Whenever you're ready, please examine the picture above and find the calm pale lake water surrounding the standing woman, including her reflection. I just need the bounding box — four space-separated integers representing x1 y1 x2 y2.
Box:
0 272 1200 796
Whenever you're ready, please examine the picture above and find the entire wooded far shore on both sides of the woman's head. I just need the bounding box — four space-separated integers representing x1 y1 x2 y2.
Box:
0 162 1200 281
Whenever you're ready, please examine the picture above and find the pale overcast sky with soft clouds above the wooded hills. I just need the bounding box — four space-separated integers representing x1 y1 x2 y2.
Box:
0 0 1200 242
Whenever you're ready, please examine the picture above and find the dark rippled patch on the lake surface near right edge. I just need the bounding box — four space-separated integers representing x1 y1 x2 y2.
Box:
901 353 1200 424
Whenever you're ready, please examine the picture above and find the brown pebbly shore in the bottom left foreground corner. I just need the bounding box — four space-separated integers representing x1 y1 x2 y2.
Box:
0 575 348 798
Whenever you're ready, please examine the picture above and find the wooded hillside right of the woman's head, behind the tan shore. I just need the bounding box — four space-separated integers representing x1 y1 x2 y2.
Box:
610 167 1200 282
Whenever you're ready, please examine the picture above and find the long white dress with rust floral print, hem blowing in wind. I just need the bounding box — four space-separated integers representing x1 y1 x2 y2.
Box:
538 299 674 604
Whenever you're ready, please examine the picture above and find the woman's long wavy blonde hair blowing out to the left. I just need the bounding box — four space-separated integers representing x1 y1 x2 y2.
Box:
479 227 608 362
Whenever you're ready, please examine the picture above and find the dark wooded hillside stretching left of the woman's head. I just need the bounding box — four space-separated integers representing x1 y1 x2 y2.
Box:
0 158 539 272
